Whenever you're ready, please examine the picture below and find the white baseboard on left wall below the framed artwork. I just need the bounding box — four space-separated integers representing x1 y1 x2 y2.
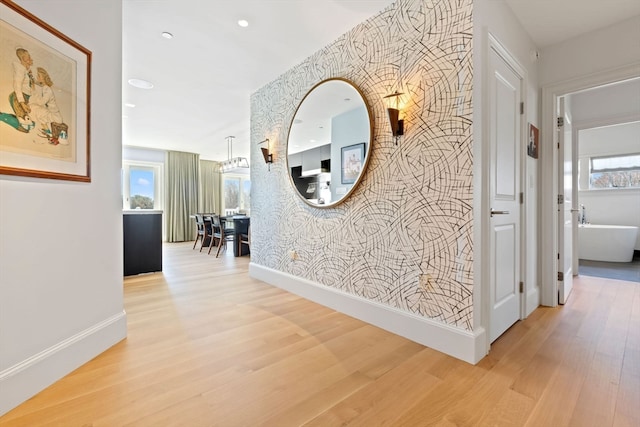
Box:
0 310 127 416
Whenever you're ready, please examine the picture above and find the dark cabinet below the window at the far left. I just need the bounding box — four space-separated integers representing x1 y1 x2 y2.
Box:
122 211 162 276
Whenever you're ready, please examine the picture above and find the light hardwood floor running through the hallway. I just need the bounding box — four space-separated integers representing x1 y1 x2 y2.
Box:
0 243 640 427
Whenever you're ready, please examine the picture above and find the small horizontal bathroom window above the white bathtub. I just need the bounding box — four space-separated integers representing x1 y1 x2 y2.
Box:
589 154 640 189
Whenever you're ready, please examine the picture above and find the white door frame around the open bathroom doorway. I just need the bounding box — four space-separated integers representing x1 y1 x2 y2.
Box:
539 64 640 307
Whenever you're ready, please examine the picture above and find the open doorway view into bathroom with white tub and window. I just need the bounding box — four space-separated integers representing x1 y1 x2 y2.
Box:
565 78 640 282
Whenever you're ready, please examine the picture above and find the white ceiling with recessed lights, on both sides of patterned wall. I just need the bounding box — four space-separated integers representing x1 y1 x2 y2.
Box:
122 0 640 160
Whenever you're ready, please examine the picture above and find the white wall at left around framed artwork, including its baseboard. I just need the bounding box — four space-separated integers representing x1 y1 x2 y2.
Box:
0 0 126 414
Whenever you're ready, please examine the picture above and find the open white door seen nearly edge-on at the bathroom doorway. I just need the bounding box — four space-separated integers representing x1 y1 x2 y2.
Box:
556 98 578 304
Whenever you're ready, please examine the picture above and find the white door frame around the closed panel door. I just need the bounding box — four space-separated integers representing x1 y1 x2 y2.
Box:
477 31 528 353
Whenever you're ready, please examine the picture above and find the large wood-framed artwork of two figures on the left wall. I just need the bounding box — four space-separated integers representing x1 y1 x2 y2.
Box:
0 0 91 182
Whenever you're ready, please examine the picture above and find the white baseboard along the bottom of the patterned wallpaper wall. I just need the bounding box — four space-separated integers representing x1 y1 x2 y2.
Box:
249 263 486 364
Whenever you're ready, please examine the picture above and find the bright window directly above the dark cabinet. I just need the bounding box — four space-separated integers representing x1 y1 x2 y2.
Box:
122 162 163 209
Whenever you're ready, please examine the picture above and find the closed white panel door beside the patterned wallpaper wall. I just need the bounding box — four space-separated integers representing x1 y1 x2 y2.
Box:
489 45 522 342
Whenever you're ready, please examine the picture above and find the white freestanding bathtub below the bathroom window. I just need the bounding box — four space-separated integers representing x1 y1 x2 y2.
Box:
578 224 638 262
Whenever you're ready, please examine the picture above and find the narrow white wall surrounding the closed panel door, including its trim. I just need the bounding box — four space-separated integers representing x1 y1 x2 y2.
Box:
473 0 540 321
